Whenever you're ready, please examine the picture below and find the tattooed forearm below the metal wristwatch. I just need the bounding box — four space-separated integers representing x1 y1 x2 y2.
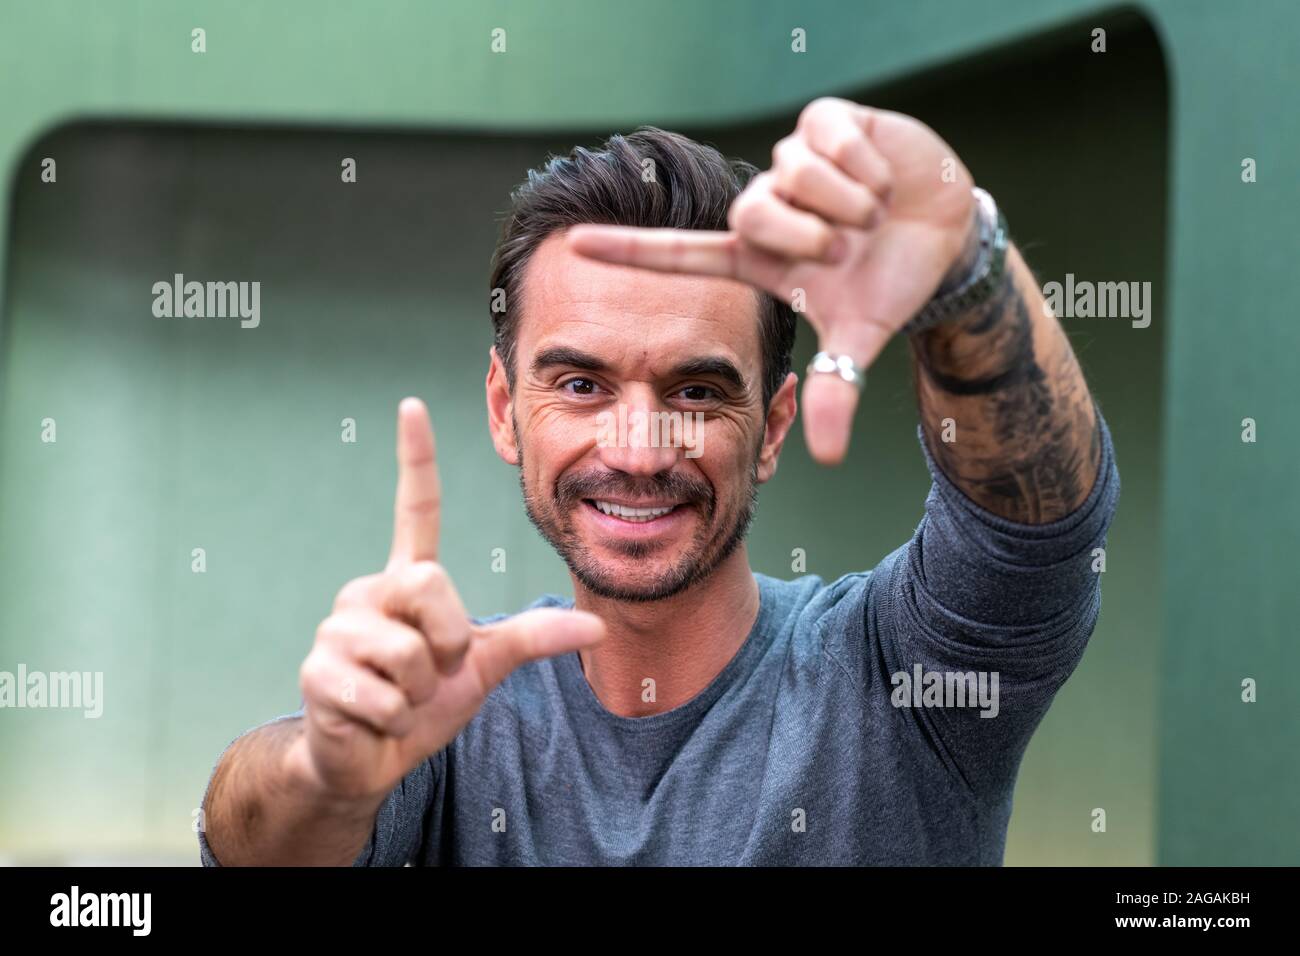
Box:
910 235 1101 524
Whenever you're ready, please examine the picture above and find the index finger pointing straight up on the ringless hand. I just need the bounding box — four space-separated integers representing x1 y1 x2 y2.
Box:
389 398 442 567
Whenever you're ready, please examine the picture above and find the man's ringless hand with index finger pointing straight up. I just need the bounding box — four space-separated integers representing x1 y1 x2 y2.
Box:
290 398 605 799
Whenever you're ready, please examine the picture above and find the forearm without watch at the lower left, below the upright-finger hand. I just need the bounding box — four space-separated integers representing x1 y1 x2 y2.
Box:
204 718 382 866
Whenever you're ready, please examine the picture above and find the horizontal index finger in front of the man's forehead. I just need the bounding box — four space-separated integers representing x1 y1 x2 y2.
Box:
568 224 741 278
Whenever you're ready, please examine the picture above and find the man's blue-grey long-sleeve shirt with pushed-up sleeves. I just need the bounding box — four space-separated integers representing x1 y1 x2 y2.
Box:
199 412 1119 866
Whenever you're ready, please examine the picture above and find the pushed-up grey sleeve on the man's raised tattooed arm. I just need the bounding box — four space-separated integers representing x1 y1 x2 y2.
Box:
866 408 1119 812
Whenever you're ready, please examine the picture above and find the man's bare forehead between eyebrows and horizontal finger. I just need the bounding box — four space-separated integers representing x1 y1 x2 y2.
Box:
516 232 761 368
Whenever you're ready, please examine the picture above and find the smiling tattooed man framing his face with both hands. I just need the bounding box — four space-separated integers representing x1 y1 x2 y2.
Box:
199 99 1119 865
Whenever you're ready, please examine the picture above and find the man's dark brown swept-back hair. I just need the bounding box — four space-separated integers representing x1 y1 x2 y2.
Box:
490 126 794 408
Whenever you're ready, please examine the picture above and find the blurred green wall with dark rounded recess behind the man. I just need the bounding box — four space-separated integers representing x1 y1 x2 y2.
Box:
0 0 1300 865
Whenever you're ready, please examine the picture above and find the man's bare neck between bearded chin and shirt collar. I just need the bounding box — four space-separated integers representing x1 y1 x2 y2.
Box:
573 545 758 717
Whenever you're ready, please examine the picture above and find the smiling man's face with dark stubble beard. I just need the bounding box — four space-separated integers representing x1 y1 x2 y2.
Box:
488 233 794 601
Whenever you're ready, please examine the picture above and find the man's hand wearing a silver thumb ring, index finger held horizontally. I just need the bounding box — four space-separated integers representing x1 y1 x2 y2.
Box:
568 98 975 463
